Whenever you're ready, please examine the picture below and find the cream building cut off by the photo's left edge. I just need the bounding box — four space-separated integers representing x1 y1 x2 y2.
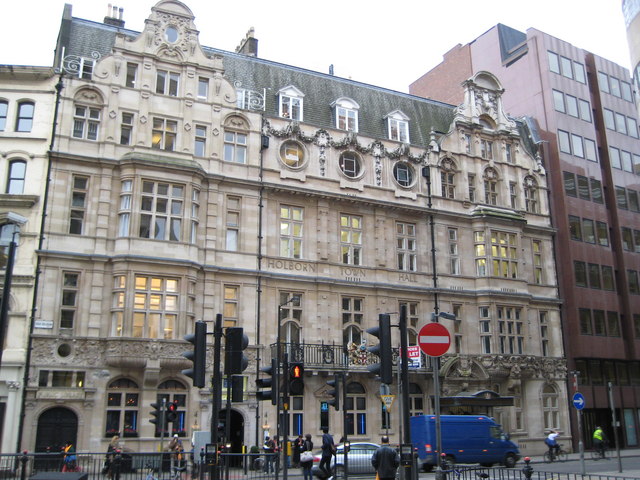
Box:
0 65 58 452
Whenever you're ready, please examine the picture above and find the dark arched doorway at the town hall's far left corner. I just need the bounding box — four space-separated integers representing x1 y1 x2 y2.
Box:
36 407 78 452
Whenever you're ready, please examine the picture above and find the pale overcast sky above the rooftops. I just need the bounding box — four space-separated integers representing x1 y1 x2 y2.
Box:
0 0 631 92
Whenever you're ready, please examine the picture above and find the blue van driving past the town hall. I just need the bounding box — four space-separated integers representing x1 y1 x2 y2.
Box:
411 415 520 472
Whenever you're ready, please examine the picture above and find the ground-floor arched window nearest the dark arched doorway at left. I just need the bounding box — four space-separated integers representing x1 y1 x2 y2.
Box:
104 378 140 437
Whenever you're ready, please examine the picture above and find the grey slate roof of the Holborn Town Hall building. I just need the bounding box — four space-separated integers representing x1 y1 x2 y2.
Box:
55 10 462 148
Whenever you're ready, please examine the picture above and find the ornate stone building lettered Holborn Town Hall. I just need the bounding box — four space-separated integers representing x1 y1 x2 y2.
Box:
12 0 568 453
